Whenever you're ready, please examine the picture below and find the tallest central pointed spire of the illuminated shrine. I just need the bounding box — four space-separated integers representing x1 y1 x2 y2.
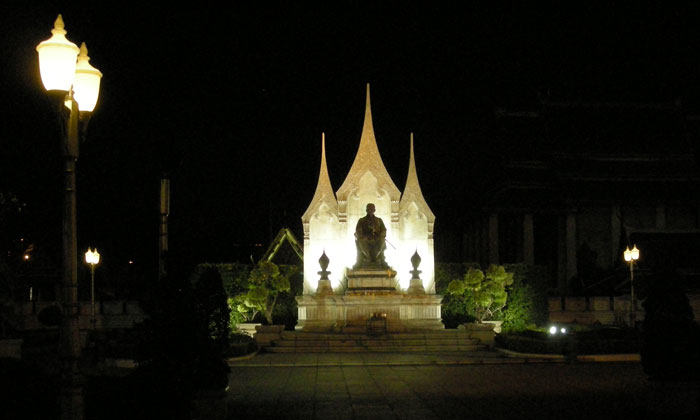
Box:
337 83 401 200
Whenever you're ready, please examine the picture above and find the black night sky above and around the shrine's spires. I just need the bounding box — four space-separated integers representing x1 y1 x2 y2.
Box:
0 1 700 276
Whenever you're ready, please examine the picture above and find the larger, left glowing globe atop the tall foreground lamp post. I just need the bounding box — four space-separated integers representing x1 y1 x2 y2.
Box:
36 15 80 92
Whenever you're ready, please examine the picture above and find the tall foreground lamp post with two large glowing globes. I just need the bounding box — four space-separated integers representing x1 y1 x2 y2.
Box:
36 15 102 419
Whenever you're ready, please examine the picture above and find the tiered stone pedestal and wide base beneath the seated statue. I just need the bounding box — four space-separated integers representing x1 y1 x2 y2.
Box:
297 269 444 333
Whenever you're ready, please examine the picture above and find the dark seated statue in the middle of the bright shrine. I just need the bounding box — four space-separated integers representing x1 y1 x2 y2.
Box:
353 203 389 269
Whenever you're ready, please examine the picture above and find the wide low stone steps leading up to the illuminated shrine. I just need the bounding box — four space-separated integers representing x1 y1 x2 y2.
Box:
265 330 489 353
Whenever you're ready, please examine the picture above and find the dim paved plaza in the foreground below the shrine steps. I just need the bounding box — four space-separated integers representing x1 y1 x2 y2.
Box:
229 353 699 420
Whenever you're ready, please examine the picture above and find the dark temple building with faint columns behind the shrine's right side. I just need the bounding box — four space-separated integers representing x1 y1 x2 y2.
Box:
462 100 700 294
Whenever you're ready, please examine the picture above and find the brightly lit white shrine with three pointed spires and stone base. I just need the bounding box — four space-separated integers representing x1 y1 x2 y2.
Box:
297 85 443 331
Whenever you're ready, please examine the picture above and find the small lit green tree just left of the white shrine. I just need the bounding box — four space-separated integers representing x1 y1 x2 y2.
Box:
246 261 299 324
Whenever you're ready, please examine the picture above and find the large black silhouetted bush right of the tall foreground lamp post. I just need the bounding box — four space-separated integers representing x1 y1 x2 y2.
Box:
127 260 229 418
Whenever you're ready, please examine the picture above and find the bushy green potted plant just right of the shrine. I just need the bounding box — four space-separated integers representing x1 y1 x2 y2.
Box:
447 265 513 338
